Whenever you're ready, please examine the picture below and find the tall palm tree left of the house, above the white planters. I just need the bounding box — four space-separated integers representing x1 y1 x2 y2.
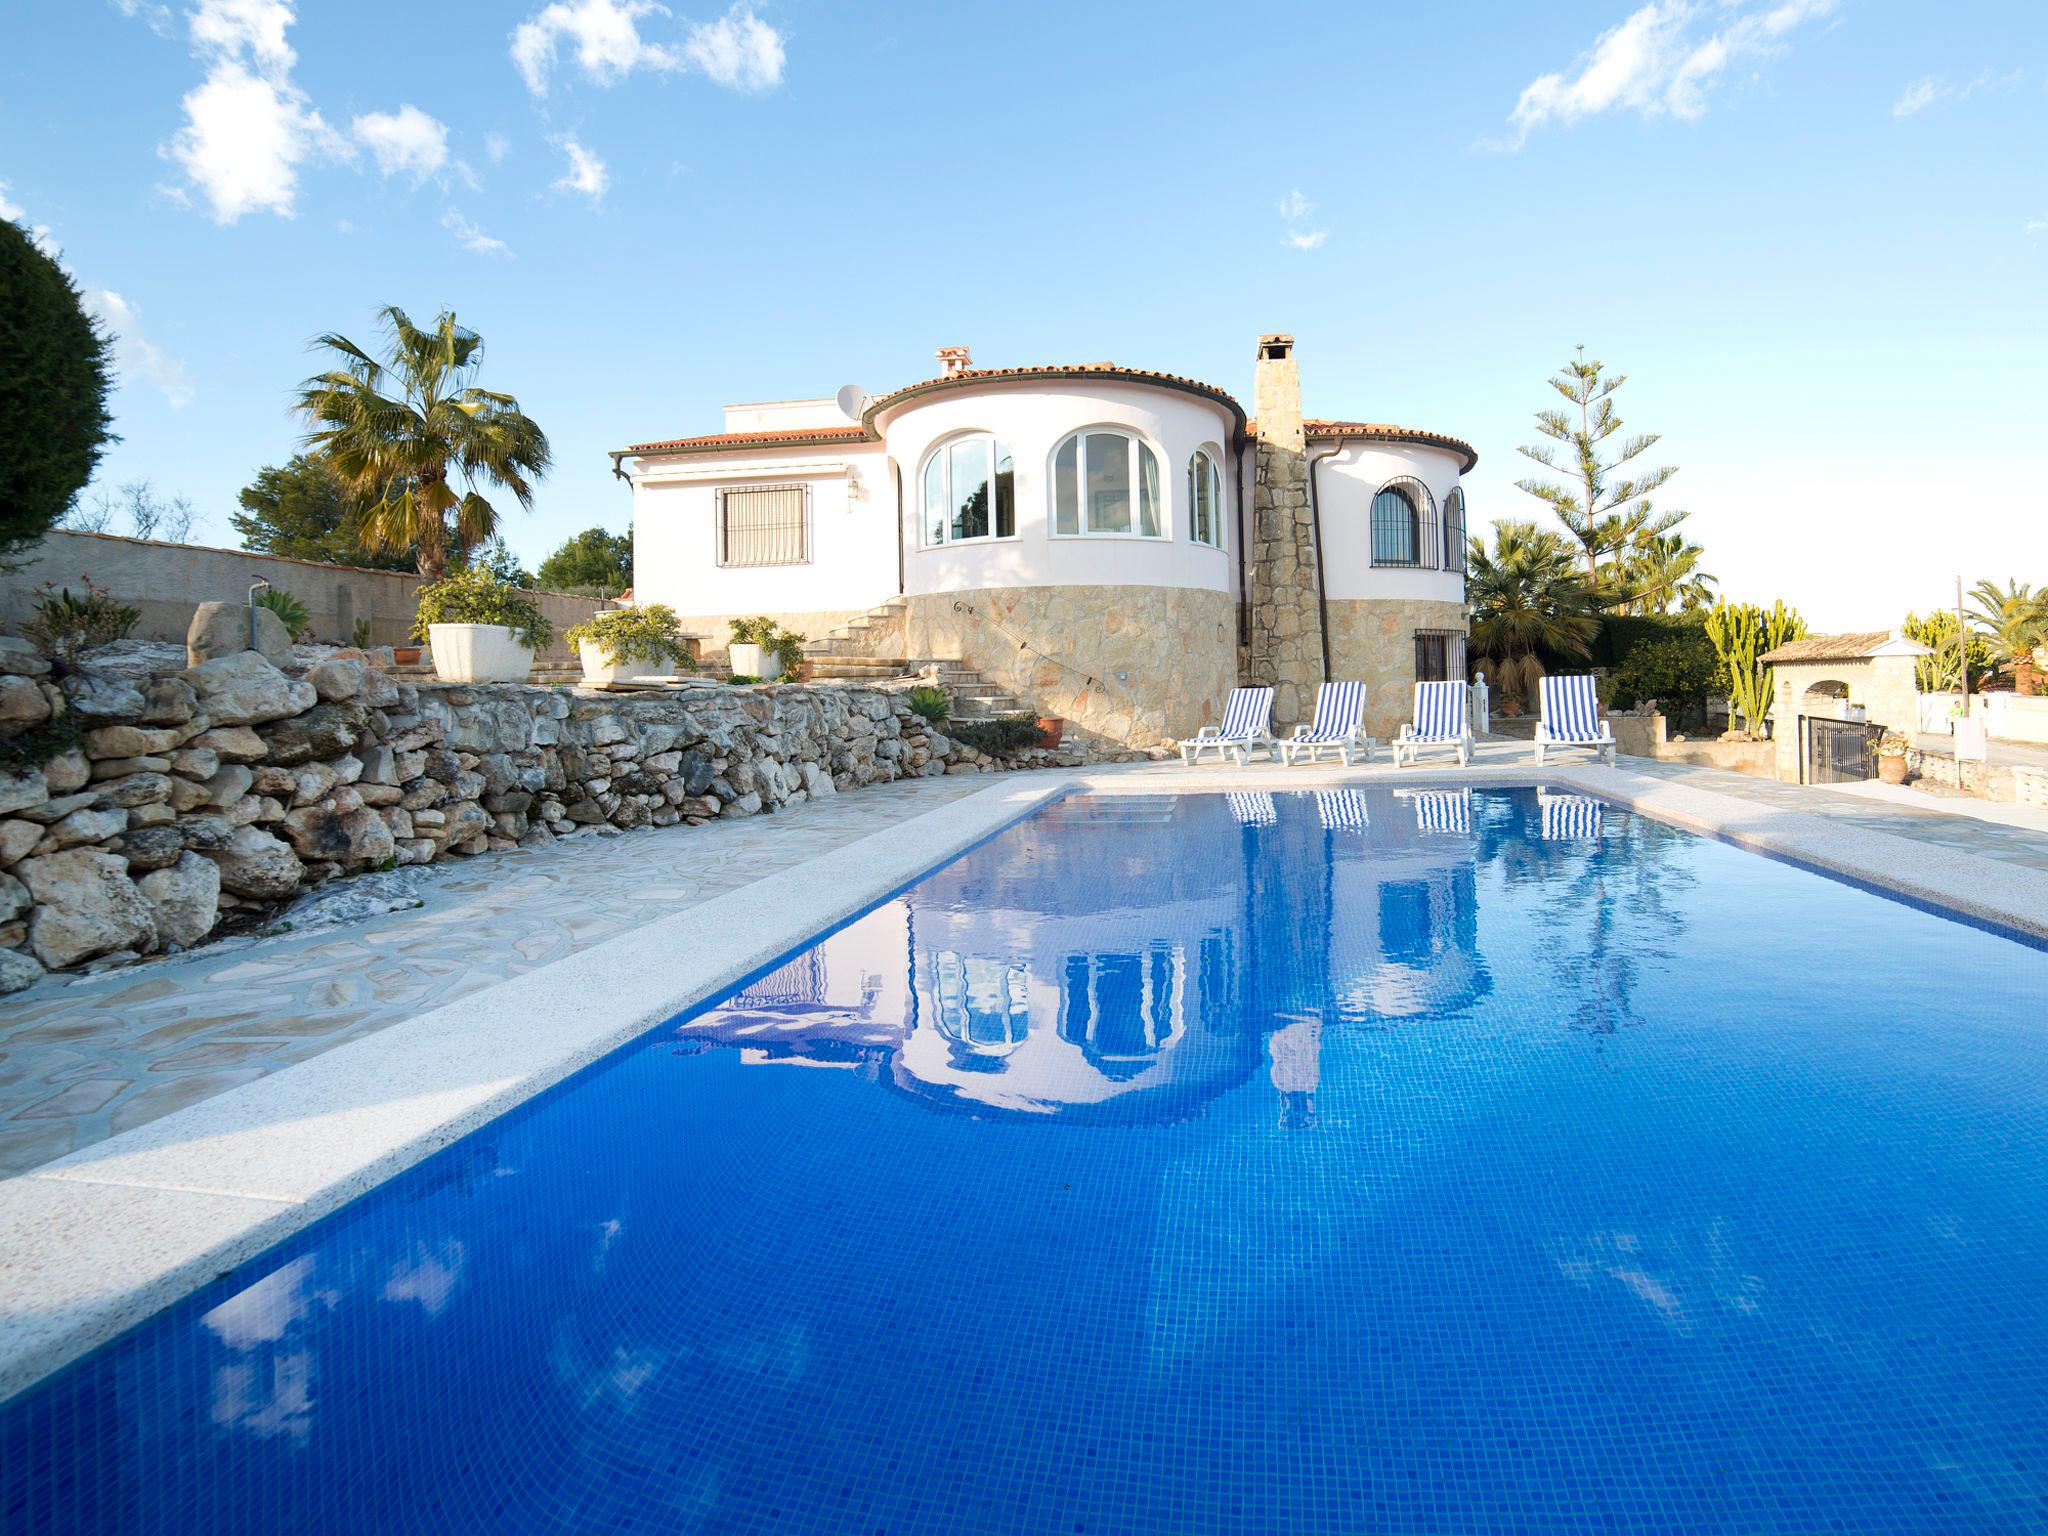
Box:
297 305 551 582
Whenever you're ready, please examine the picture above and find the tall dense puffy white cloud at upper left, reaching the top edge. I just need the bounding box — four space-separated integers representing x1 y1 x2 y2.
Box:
164 0 354 223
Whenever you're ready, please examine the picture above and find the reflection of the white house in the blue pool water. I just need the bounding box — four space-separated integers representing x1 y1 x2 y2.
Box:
678 795 1489 1124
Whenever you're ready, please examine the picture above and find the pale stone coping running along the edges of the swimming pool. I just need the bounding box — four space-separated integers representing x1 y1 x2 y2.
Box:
0 764 2048 1399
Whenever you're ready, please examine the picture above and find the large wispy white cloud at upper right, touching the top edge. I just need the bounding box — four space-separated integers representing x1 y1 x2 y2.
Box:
1483 0 1837 150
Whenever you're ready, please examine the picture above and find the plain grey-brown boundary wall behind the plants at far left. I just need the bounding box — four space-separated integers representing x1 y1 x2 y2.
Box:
0 528 606 664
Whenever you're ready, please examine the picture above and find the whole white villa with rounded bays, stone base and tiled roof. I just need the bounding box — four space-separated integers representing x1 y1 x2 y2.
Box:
612 334 1477 745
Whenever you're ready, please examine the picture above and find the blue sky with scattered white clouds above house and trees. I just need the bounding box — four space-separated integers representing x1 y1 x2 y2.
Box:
0 0 2048 627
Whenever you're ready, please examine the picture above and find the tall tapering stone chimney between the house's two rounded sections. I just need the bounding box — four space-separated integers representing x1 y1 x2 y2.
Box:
1243 334 1323 729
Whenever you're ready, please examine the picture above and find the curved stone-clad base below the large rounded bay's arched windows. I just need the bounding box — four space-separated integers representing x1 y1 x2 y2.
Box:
905 586 1237 748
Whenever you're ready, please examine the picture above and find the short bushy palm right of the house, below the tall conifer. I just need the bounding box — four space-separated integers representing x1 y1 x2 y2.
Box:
1464 520 1599 702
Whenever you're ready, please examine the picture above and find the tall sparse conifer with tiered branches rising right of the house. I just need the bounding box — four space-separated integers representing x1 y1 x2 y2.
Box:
1516 346 1686 582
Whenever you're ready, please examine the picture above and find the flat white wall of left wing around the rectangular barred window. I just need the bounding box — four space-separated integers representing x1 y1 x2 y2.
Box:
631 442 897 622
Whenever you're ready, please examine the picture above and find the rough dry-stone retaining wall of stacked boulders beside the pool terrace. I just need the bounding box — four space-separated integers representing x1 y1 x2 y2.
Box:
0 639 1056 991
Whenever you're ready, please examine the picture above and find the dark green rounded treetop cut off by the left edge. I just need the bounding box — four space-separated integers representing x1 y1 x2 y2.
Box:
0 219 119 569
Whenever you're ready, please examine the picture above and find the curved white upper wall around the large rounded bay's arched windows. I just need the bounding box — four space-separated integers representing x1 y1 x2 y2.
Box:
877 379 1237 594
